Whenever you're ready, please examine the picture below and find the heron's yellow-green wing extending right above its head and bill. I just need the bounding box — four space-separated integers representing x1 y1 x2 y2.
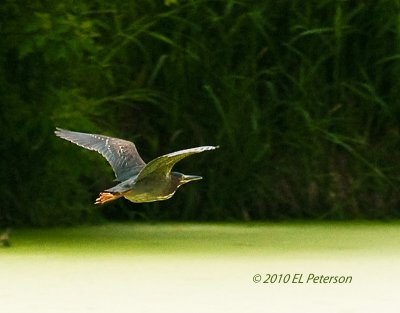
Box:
136 146 218 181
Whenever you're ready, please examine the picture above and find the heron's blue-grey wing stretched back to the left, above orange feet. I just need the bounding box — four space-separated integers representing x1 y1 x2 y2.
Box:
55 128 146 181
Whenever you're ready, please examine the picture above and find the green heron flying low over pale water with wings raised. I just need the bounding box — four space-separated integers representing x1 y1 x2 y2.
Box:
55 128 218 204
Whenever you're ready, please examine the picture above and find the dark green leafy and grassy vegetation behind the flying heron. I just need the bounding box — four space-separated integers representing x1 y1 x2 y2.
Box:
0 0 400 225
